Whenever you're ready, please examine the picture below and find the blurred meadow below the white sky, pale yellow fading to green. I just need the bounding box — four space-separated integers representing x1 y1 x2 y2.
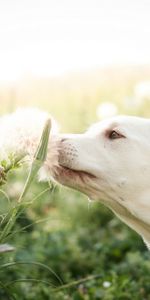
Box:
0 66 150 300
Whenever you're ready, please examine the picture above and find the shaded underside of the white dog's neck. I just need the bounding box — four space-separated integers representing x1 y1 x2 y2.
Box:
101 201 150 249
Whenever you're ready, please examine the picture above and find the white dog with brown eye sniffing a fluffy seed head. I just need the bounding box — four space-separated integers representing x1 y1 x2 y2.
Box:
54 116 150 247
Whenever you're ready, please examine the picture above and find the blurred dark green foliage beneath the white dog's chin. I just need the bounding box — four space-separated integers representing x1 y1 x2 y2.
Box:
0 179 150 300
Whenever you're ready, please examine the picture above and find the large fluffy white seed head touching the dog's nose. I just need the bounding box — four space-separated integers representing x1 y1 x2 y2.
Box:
0 108 58 179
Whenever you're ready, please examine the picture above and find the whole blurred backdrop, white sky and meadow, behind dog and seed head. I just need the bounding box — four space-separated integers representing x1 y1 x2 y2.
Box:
0 0 150 300
